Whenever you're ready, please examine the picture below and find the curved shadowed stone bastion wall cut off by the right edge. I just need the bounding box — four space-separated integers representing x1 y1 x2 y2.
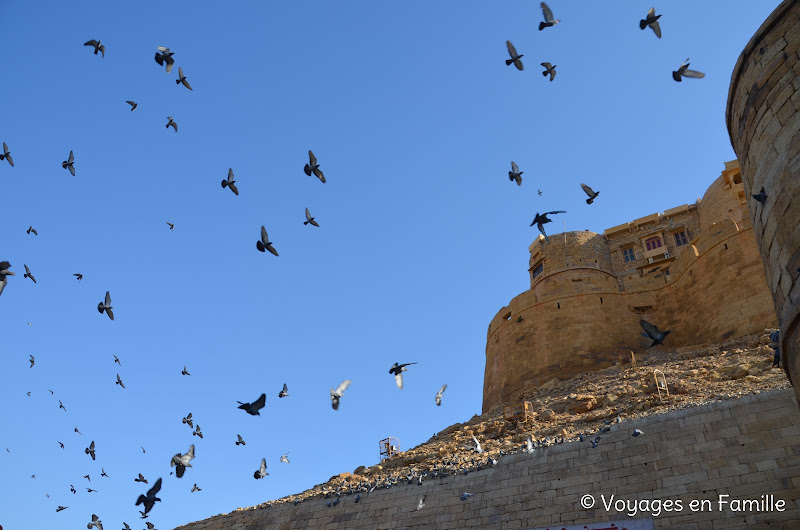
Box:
726 0 800 406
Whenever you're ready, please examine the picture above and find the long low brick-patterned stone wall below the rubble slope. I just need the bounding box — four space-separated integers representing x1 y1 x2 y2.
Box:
173 390 800 530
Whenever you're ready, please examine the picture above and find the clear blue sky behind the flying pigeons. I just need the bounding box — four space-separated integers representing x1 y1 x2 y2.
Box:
0 0 778 530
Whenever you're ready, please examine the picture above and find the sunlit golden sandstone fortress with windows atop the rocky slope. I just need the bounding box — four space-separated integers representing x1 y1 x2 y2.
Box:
483 161 776 412
